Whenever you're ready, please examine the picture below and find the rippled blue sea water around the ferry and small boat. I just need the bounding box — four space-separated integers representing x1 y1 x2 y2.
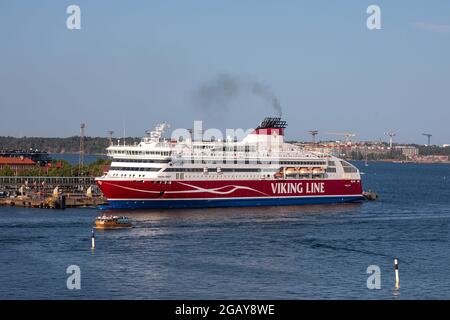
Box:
0 163 450 299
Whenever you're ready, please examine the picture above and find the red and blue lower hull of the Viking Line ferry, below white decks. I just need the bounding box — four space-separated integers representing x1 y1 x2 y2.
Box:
97 178 364 209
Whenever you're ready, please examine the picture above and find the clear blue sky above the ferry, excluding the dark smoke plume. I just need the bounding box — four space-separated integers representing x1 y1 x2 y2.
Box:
0 0 450 143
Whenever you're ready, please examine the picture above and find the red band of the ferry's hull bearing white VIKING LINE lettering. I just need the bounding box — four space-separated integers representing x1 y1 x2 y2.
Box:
97 179 362 200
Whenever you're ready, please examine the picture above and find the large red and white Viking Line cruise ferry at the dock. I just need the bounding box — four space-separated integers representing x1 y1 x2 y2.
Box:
96 117 364 209
